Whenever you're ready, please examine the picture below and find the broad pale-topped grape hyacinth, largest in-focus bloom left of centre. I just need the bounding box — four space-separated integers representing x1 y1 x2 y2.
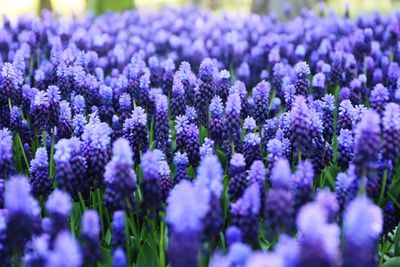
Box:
81 117 111 189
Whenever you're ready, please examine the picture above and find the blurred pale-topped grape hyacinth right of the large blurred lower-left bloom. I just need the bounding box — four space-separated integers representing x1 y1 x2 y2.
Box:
45 189 72 239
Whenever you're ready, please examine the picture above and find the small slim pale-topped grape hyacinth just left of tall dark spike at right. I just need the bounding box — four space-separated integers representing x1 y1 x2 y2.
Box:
337 129 354 170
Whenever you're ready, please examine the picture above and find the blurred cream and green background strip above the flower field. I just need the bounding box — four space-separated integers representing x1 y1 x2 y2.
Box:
0 0 400 19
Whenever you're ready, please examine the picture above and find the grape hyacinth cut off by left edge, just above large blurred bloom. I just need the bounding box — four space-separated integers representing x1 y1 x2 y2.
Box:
0 128 14 177
